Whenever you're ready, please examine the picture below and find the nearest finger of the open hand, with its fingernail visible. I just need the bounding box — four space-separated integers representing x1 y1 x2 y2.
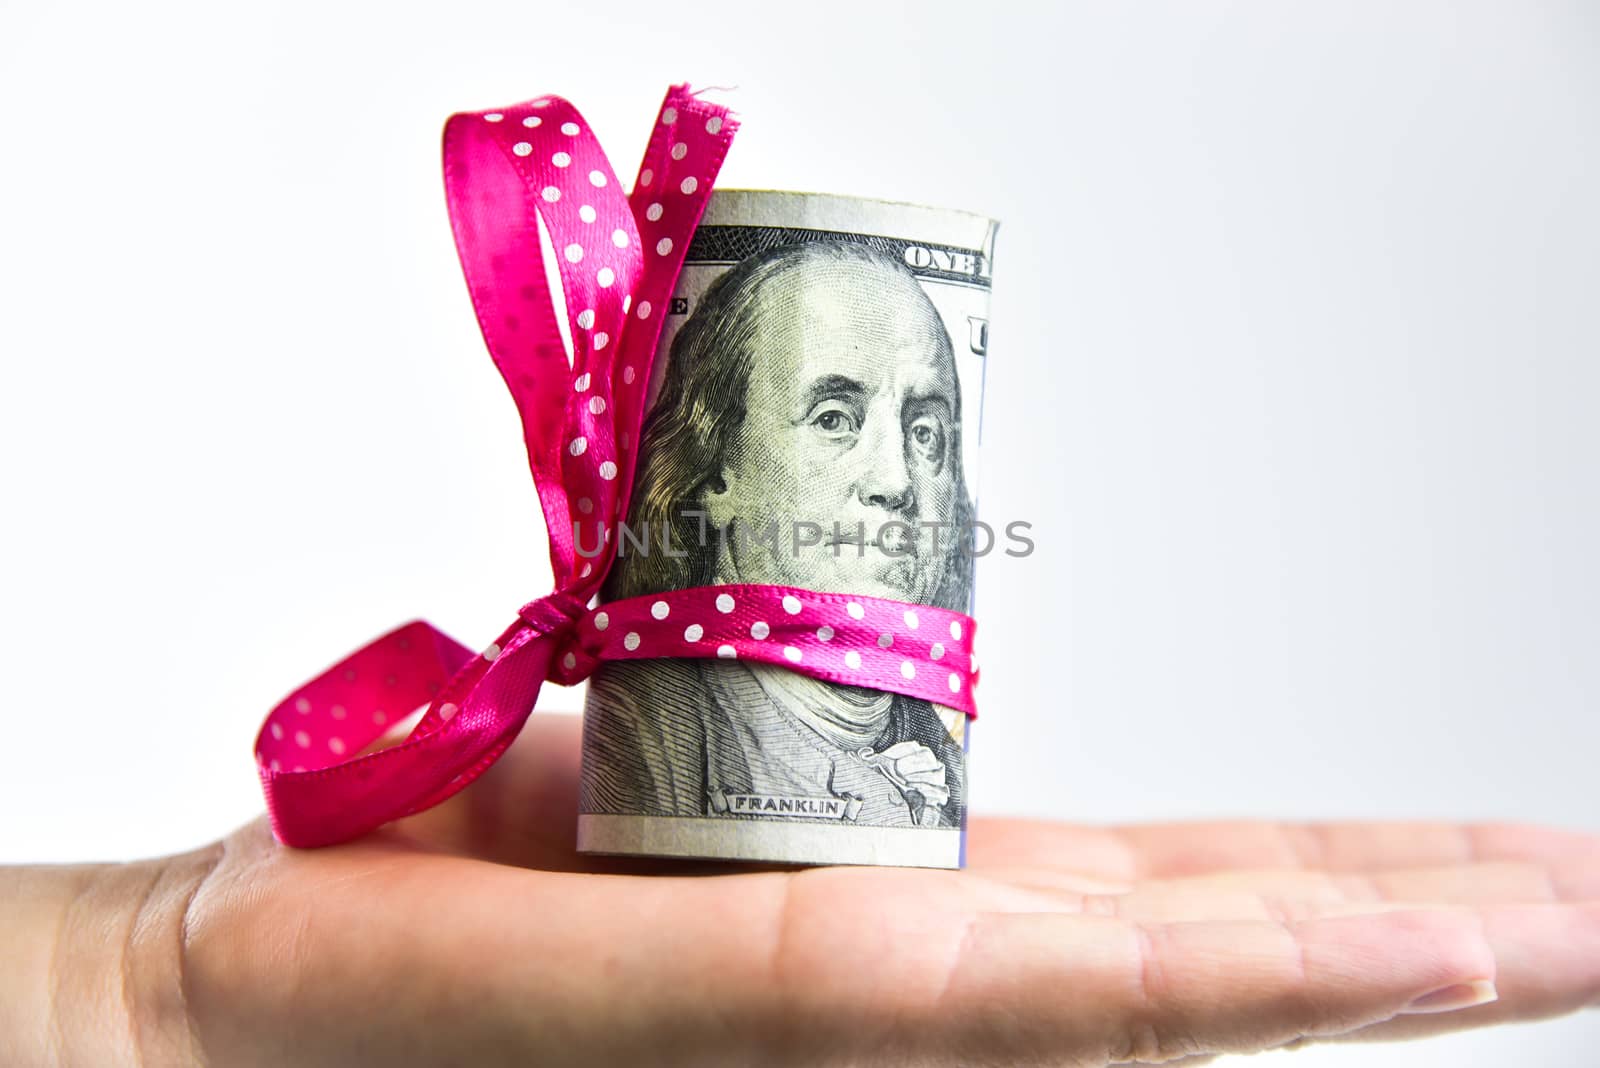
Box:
915 910 1494 1063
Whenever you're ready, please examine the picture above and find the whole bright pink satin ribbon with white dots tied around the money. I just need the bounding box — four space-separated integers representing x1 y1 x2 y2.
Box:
256 86 978 847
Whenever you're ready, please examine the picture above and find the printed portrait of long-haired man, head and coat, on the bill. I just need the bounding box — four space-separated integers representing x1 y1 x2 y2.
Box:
581 240 971 828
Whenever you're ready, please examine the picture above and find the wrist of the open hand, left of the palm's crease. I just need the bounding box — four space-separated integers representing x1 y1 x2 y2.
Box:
0 851 214 1065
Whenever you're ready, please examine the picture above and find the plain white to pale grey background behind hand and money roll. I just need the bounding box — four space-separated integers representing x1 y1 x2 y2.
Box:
0 0 1600 1068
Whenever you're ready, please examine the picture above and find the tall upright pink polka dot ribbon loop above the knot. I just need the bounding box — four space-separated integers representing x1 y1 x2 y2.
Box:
443 96 643 600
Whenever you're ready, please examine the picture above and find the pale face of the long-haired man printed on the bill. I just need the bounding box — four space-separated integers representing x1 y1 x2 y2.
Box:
704 262 960 603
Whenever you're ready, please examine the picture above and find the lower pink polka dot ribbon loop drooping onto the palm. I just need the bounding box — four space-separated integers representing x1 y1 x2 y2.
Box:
256 622 558 847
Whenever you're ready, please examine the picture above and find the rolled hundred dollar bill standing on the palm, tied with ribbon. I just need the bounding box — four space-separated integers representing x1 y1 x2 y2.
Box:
578 190 995 868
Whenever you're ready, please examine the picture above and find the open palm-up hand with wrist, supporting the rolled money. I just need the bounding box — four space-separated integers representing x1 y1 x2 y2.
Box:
9 715 1600 1066
